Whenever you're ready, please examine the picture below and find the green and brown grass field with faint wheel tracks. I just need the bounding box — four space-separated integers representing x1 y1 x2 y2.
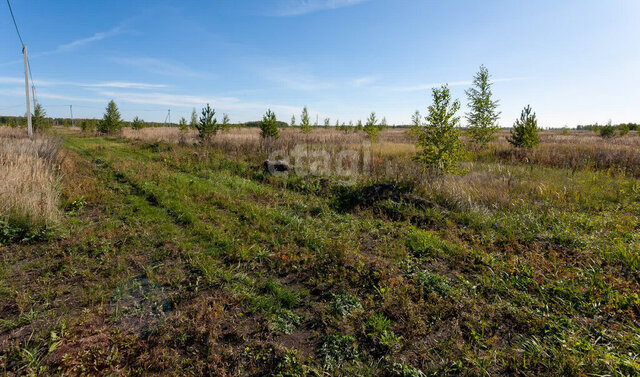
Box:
0 129 640 376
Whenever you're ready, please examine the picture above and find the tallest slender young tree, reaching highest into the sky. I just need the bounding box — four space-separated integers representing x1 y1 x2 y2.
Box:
465 65 500 147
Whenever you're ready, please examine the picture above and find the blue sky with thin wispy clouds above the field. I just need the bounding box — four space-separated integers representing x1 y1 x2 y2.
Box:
0 0 640 127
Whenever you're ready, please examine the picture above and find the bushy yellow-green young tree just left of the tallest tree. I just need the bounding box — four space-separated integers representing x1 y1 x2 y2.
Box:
414 85 462 177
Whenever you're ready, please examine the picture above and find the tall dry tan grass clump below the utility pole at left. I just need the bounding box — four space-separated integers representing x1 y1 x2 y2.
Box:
0 127 61 229
